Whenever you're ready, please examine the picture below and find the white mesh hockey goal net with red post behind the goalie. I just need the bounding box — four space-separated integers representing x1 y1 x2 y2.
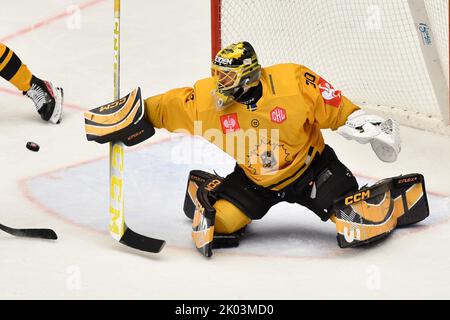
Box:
211 0 450 134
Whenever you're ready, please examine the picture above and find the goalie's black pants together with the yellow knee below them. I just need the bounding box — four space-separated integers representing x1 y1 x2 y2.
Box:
214 145 358 234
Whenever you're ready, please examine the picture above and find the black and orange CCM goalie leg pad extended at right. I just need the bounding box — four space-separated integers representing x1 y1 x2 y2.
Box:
334 174 429 248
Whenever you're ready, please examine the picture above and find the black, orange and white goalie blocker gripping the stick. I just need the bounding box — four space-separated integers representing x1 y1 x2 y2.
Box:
84 88 155 146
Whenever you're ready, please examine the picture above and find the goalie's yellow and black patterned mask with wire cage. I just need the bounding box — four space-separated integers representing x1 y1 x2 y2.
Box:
211 42 261 109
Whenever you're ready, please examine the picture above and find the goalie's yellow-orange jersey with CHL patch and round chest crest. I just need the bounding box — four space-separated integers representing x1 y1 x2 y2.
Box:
145 64 359 190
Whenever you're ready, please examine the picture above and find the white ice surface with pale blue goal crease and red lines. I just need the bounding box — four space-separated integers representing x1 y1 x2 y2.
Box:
0 0 450 299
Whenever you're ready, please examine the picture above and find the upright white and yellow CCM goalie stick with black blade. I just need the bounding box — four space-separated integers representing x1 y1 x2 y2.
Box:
109 0 165 252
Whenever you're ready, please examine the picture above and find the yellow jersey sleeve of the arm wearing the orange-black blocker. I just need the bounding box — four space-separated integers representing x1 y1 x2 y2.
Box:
145 88 197 134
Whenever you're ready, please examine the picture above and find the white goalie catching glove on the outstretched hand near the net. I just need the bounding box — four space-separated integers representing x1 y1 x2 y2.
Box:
337 110 401 162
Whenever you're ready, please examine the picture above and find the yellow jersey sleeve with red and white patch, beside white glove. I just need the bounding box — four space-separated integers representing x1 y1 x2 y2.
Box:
300 66 359 130
